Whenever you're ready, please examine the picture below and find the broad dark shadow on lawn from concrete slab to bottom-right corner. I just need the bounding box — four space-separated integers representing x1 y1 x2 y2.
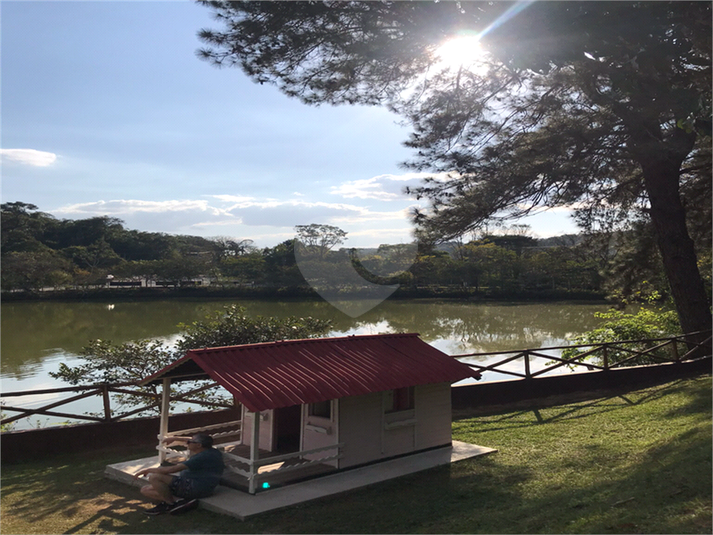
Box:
270 422 711 533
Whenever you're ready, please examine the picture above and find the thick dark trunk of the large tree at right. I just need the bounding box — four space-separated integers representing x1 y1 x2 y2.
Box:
642 158 711 340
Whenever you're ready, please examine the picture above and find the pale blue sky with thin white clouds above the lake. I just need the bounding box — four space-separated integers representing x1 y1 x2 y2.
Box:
0 0 577 247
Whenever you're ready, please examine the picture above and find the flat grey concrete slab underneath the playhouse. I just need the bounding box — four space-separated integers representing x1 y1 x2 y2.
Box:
105 440 497 520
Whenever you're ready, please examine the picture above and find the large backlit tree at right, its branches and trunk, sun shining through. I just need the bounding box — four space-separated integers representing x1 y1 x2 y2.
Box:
199 1 711 338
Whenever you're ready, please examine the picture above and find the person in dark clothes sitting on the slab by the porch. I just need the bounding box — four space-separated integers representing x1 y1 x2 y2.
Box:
134 434 224 515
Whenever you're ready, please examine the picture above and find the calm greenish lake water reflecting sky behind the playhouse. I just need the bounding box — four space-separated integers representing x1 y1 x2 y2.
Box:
0 299 608 429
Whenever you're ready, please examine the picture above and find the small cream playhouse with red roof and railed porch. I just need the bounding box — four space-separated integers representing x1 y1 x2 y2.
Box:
136 334 480 494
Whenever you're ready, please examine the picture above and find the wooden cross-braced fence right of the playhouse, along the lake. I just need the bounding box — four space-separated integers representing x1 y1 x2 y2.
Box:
453 331 711 379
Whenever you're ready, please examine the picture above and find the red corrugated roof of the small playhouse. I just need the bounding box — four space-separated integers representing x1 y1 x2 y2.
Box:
142 334 480 411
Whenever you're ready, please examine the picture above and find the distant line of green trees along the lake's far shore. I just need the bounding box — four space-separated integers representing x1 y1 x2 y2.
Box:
1 202 710 299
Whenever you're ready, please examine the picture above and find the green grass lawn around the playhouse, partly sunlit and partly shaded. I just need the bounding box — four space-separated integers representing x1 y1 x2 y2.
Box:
0 376 712 534
